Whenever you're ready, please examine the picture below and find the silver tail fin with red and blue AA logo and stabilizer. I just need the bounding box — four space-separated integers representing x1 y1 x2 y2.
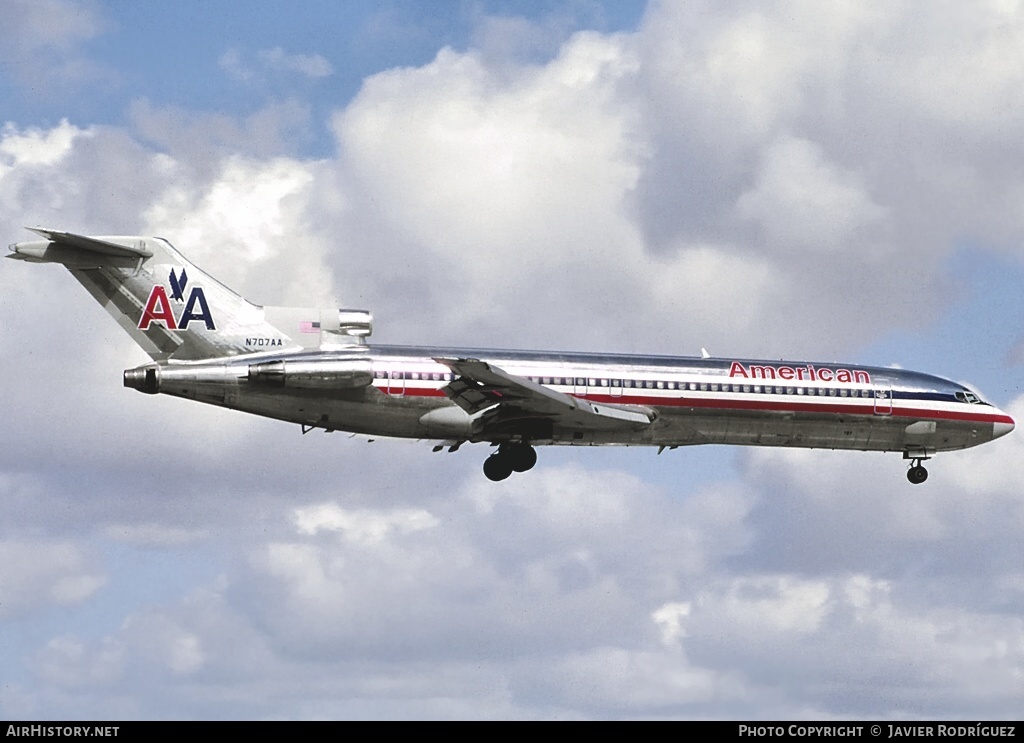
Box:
7 229 371 361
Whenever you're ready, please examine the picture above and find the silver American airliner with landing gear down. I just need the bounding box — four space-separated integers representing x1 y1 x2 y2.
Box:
7 228 1014 484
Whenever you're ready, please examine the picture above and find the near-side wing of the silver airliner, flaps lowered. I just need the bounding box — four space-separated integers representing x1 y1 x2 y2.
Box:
434 358 656 431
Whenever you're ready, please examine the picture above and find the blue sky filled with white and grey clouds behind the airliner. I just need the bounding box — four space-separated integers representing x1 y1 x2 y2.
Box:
0 0 1024 719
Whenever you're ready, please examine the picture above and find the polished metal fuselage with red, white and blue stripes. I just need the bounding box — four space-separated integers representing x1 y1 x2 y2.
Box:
125 346 1013 456
